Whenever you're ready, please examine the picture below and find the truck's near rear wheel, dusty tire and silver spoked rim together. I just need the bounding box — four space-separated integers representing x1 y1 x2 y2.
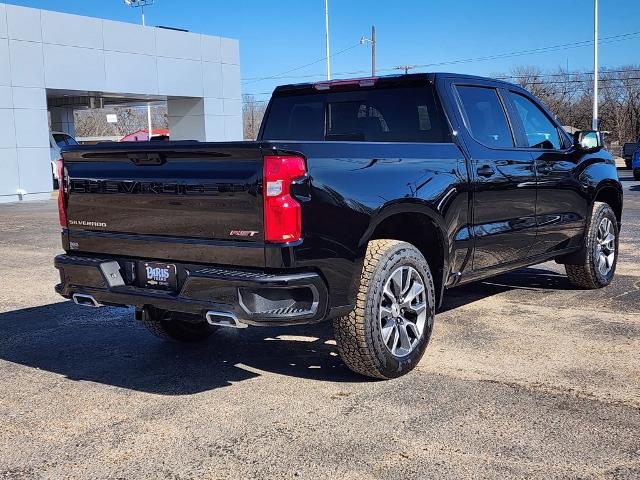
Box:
333 240 435 379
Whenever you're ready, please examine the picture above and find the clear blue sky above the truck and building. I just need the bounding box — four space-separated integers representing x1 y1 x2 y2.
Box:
7 0 640 98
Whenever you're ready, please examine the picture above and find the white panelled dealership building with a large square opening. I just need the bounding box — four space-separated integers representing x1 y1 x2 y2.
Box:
0 3 242 202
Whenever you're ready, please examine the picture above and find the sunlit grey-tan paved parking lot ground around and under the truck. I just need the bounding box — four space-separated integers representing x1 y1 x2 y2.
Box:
0 171 640 479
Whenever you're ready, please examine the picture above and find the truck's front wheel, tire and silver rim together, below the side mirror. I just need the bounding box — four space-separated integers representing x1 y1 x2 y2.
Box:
565 202 618 289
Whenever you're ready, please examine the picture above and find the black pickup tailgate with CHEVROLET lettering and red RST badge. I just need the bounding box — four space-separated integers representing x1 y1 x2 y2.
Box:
63 142 264 265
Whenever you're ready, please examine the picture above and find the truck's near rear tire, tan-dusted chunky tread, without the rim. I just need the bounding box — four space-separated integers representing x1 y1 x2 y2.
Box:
333 240 435 379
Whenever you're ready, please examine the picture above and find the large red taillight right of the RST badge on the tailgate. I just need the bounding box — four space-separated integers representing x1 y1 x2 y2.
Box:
263 156 307 243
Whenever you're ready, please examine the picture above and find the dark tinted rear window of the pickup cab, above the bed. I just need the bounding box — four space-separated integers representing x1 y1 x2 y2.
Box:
262 86 451 143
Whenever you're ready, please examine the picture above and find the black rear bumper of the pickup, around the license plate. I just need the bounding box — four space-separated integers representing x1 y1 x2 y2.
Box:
54 255 328 325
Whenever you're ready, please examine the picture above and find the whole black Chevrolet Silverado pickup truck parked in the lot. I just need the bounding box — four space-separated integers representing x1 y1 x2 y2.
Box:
55 73 622 378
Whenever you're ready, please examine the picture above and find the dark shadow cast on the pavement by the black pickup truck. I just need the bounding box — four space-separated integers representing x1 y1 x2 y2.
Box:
0 268 569 395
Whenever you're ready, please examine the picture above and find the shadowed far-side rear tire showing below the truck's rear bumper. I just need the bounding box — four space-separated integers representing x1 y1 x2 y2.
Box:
140 309 216 343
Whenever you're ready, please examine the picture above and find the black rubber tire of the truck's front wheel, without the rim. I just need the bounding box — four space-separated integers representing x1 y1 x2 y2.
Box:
565 202 618 290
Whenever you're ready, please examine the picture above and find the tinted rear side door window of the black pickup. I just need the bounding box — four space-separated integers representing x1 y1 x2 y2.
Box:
456 86 513 147
